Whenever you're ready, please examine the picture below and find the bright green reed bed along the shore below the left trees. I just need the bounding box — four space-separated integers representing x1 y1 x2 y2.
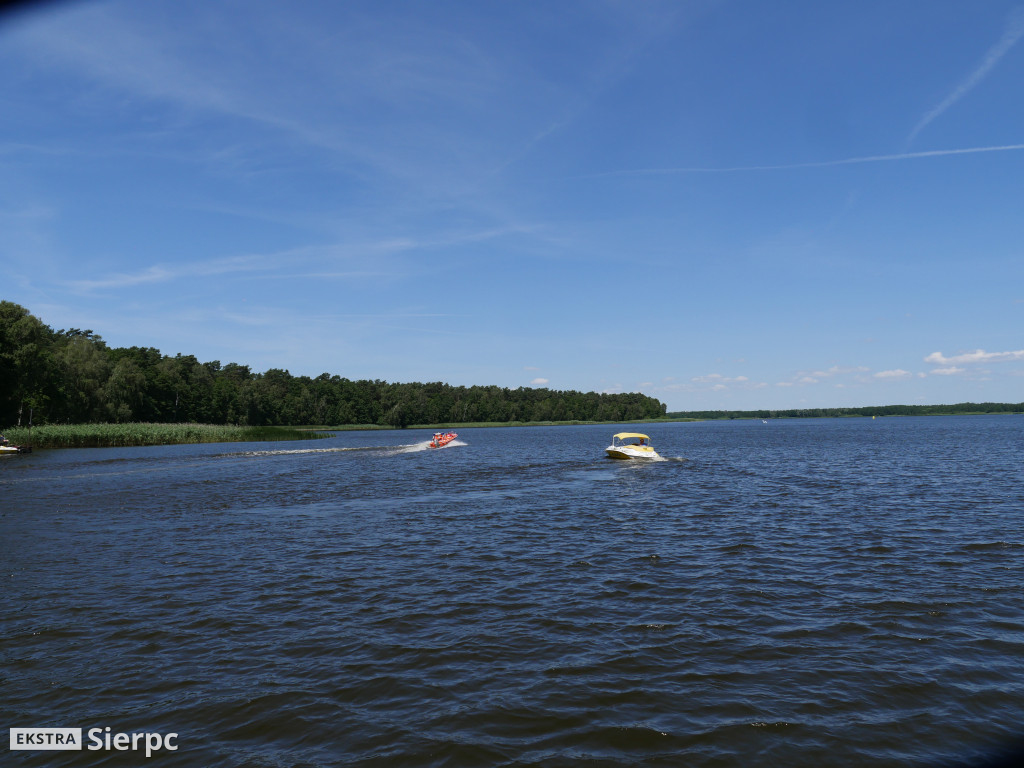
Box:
4 422 326 449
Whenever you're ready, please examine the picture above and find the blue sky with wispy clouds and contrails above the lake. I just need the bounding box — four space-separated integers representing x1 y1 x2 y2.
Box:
0 0 1024 411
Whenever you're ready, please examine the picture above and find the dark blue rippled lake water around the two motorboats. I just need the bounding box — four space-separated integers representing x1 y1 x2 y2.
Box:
0 417 1024 766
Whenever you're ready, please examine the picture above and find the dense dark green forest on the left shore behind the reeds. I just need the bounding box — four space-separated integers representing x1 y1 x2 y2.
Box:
0 301 666 427
